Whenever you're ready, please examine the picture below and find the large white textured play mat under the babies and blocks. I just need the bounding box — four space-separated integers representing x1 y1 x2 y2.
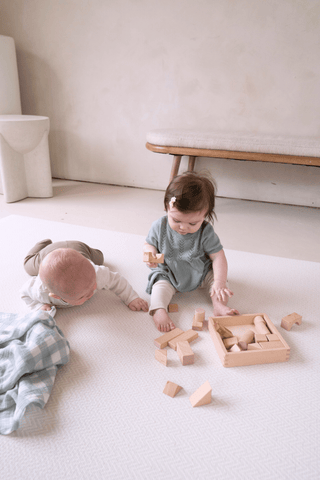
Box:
0 215 320 480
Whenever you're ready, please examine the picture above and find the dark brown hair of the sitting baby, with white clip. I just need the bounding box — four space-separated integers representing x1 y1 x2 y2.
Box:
164 172 217 223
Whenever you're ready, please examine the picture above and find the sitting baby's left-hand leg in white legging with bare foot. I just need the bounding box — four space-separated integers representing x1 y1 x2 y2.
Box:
149 280 176 332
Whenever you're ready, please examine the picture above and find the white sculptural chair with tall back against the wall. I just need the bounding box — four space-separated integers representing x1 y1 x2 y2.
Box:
0 35 53 203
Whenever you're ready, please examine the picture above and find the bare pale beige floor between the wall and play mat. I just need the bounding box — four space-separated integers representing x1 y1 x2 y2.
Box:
0 180 320 262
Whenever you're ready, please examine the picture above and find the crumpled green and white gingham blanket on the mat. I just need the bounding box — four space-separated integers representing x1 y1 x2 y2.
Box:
0 310 70 434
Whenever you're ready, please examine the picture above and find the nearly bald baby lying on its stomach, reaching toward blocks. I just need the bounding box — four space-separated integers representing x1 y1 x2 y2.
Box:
20 240 148 312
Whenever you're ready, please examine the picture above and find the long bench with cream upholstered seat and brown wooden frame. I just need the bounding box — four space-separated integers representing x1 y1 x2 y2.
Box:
146 129 320 181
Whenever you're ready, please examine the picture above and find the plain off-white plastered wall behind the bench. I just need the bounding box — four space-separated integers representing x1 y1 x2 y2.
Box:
0 0 320 206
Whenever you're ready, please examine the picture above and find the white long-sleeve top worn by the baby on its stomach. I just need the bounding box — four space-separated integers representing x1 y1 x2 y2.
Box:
20 262 139 310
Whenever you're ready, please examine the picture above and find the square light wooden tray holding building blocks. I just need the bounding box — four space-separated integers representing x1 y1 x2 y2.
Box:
208 313 290 367
